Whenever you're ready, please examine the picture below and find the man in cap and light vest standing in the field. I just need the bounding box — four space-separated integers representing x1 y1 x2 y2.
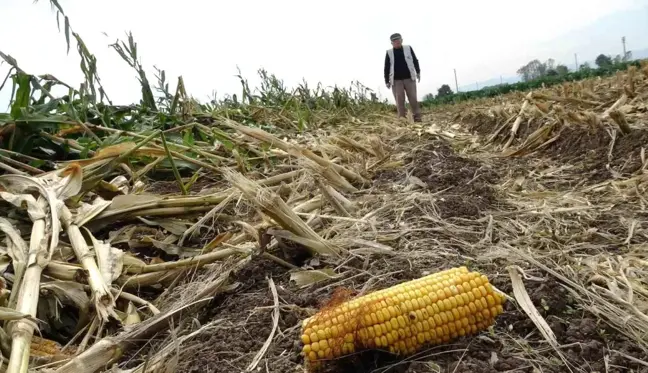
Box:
385 34 421 122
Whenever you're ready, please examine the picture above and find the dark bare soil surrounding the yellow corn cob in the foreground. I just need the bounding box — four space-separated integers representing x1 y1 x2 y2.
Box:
172 253 644 373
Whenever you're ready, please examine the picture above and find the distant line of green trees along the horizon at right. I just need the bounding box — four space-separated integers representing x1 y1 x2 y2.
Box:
422 48 639 106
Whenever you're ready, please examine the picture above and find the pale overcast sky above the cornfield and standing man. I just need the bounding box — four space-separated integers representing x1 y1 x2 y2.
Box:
0 0 648 108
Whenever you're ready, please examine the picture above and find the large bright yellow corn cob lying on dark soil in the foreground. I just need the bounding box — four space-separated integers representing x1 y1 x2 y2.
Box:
301 267 505 363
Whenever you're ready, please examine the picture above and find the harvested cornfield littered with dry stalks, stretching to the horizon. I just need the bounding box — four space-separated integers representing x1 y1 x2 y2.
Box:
0 4 648 373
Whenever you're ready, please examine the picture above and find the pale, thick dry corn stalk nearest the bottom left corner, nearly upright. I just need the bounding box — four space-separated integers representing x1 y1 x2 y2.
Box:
7 219 47 373
